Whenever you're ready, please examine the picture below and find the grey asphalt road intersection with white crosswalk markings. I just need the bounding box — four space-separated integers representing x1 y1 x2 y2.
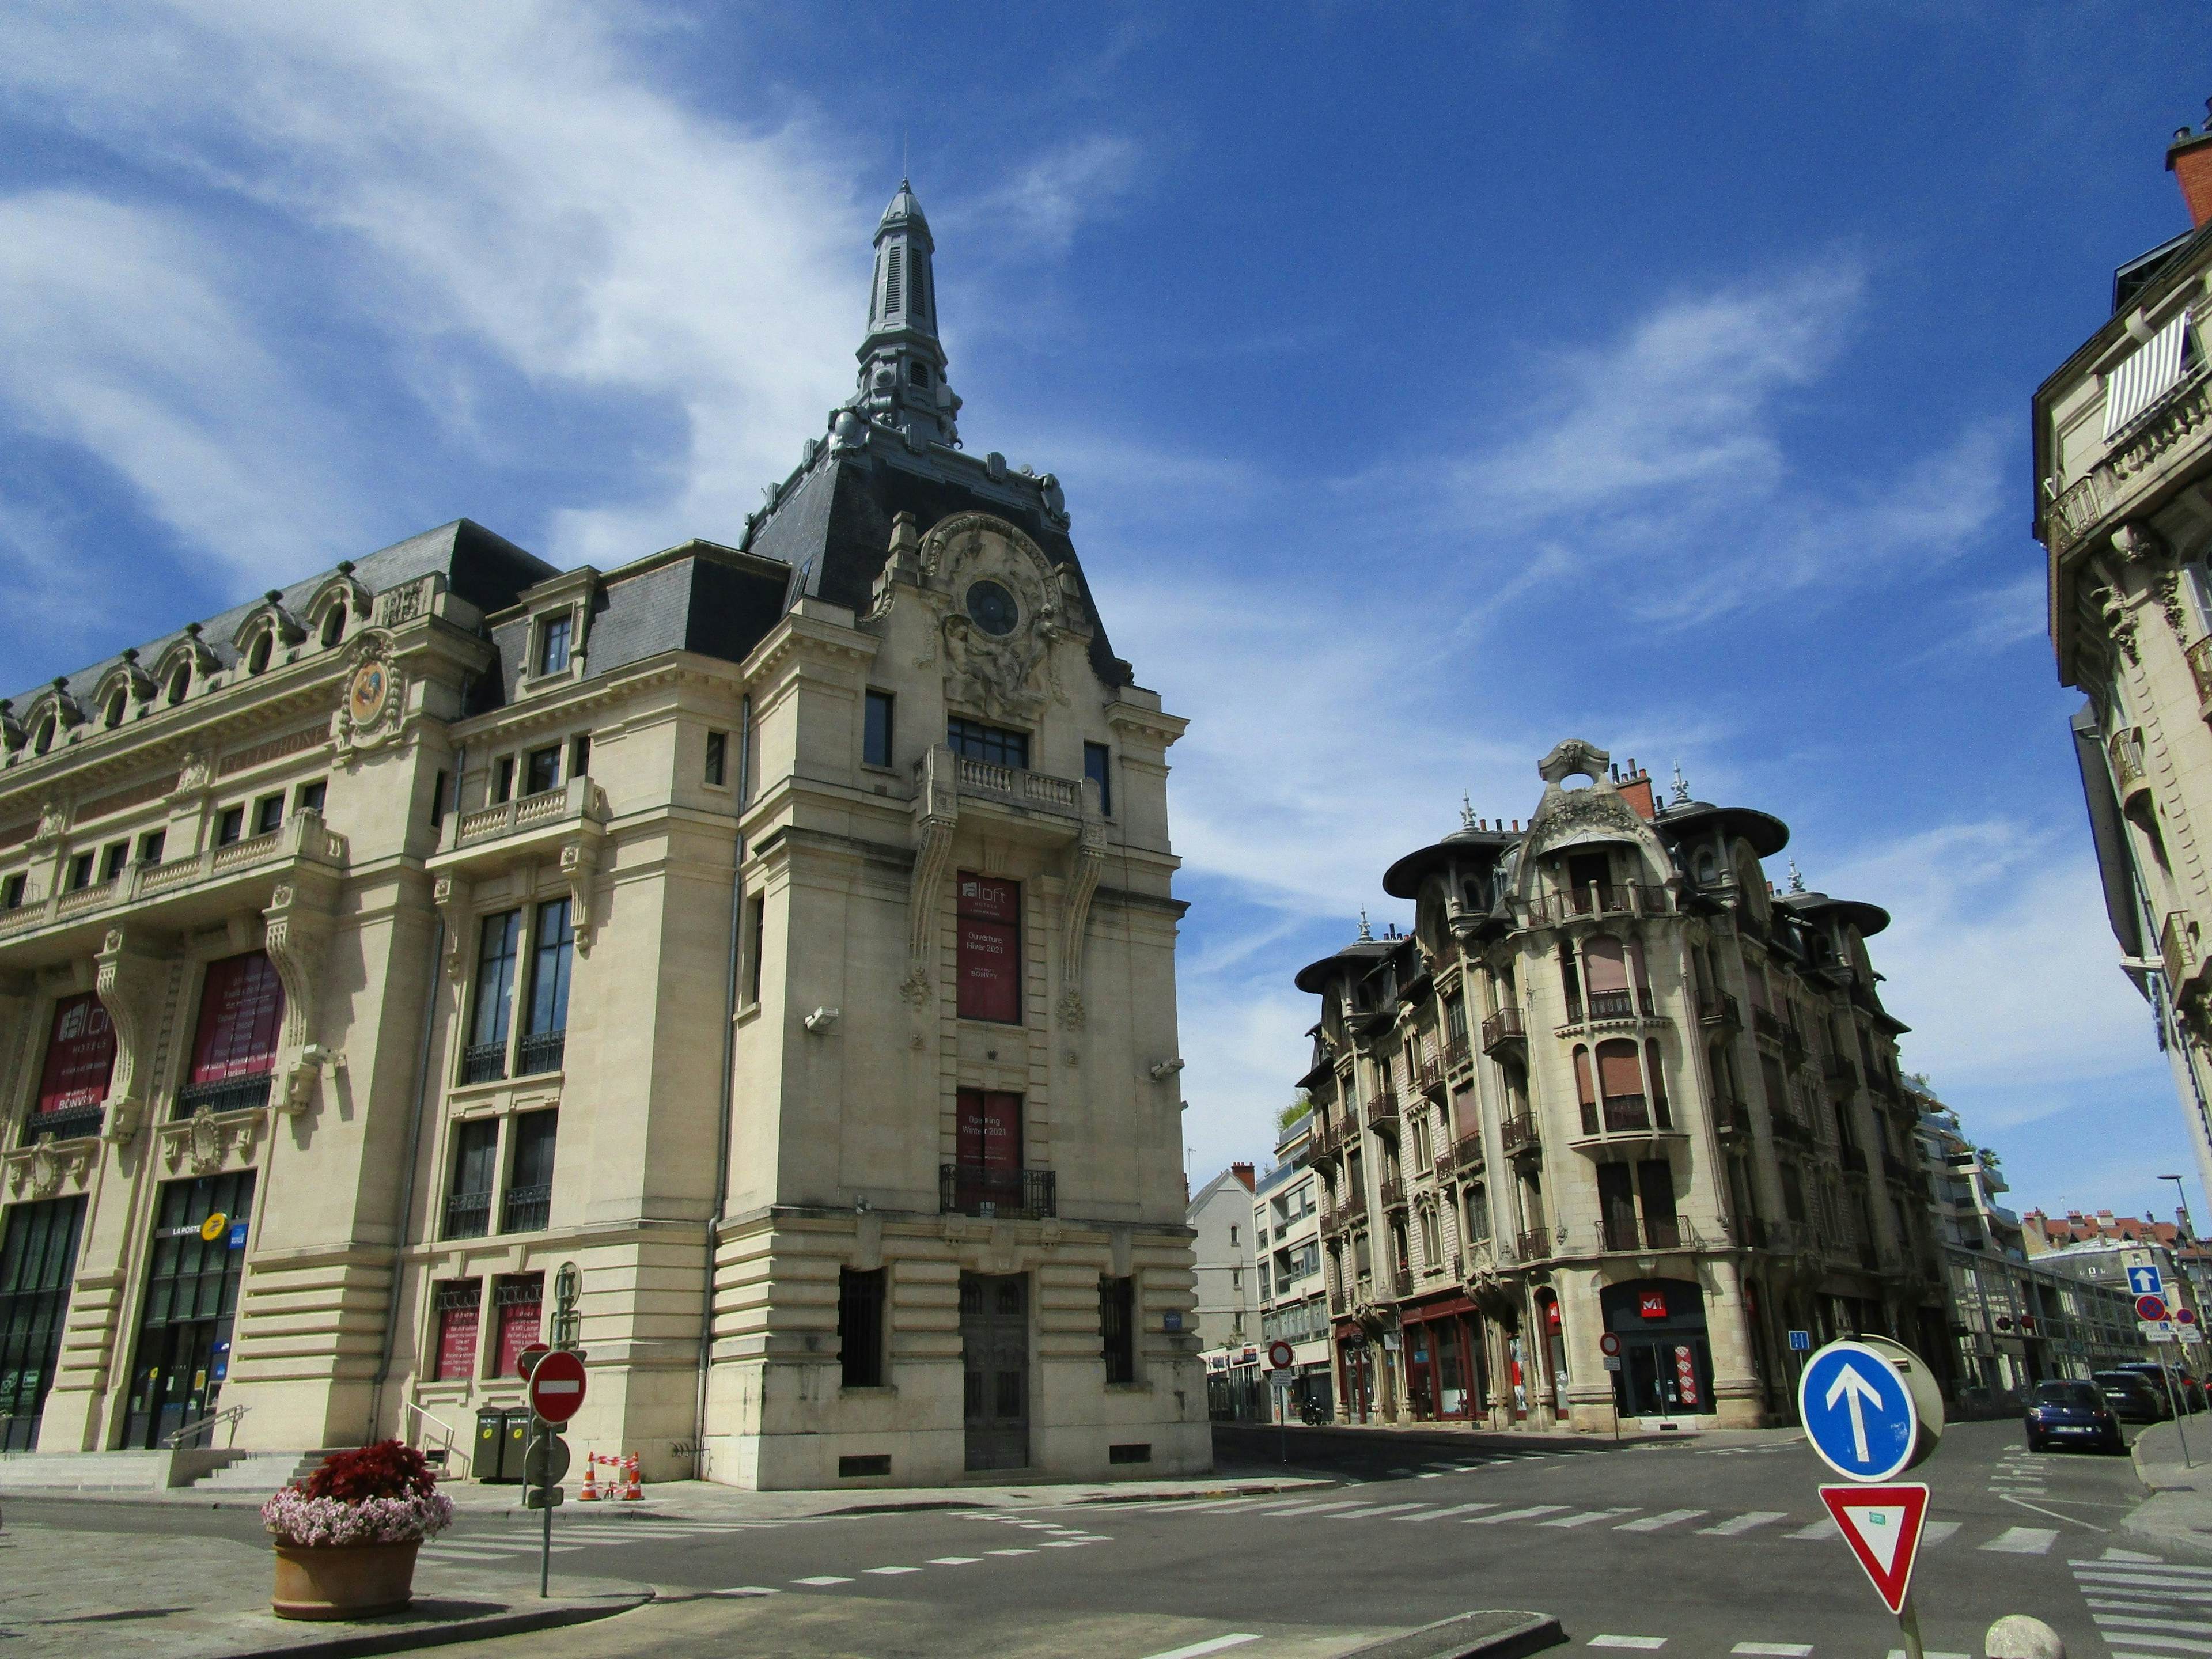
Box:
9 1422 2168 1659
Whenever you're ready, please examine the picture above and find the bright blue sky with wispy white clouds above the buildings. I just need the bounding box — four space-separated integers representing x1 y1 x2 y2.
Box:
0 2 2212 1217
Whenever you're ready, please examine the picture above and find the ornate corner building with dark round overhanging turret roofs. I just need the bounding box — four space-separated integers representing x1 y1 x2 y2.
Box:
1296 741 1951 1429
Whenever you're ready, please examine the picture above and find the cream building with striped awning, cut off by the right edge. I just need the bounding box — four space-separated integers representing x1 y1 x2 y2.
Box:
2033 111 2212 1190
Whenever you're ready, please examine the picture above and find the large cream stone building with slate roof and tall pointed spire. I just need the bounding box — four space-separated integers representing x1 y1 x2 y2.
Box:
0 188 1210 1486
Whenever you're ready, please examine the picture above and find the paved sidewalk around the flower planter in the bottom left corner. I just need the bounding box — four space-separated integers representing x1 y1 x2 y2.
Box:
0 1524 653 1659
